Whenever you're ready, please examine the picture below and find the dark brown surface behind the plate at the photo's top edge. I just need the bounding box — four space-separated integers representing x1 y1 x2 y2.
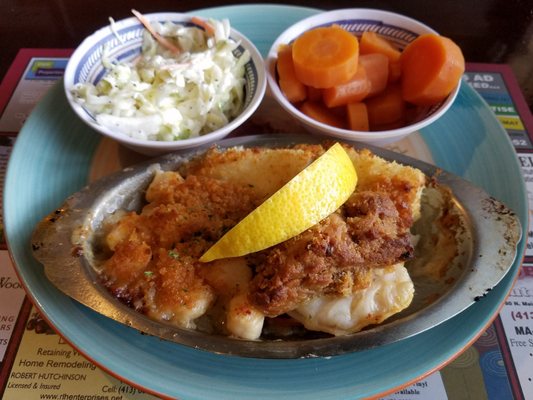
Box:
0 0 533 110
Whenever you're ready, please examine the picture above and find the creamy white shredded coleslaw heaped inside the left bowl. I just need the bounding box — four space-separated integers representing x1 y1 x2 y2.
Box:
72 19 250 141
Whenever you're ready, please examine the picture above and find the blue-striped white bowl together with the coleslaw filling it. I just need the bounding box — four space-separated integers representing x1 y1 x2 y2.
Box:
64 10 266 155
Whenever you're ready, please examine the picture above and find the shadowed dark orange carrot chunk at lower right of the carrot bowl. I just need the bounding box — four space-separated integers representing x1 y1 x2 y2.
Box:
366 84 406 130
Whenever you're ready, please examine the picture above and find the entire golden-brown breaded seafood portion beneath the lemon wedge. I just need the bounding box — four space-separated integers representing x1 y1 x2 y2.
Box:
103 145 425 339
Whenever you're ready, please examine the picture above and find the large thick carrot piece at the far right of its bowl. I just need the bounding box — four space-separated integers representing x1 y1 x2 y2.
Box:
401 33 465 105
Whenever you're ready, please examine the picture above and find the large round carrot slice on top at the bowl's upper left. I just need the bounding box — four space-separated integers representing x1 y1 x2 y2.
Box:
292 25 359 88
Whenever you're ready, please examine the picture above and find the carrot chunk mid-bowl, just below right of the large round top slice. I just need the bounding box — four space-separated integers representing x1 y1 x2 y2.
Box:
322 65 370 108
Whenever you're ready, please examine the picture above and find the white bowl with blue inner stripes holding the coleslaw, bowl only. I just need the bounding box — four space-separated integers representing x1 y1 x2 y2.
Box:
64 13 267 155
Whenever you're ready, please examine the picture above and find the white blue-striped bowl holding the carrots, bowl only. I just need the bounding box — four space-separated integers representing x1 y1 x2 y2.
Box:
266 8 461 146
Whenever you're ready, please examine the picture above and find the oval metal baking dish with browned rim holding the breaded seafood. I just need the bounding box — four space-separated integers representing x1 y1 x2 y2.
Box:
28 135 522 358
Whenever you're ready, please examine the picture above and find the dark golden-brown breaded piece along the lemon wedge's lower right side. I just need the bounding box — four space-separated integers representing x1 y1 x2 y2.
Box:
245 149 425 316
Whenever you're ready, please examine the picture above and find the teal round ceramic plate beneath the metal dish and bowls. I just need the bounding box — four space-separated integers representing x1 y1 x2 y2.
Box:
4 5 528 400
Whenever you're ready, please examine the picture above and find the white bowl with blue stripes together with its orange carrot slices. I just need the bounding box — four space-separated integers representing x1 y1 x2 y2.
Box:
266 9 465 145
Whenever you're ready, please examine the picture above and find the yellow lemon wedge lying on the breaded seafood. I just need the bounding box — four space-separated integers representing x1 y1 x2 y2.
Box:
200 143 357 262
